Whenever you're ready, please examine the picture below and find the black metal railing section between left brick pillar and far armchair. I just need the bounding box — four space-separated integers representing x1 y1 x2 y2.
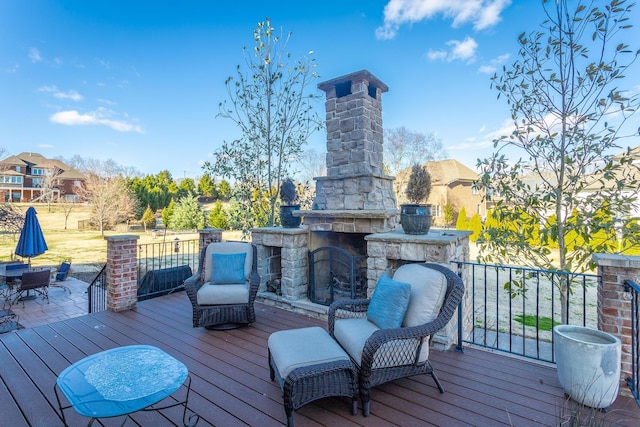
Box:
138 237 195 300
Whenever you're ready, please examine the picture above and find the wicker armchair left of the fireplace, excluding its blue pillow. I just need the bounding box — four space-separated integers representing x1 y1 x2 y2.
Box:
184 242 260 330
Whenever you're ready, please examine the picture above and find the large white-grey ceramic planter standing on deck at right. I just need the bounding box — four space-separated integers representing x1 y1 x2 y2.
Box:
553 325 621 409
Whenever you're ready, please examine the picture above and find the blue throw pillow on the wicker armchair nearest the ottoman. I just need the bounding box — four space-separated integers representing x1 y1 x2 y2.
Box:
367 275 411 329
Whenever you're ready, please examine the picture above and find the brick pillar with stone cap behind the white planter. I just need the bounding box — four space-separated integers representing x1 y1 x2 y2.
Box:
593 254 640 396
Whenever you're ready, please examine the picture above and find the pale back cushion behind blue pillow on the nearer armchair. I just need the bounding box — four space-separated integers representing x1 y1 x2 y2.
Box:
393 264 447 326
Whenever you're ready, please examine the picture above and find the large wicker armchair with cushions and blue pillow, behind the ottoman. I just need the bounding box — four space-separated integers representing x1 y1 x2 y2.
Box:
328 263 464 416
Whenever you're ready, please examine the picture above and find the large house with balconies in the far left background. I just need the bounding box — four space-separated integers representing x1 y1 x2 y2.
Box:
0 152 84 202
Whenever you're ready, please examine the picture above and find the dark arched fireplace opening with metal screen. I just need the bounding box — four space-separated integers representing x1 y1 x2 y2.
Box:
307 246 367 305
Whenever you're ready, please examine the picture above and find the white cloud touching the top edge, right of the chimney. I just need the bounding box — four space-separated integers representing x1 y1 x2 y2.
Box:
376 0 511 40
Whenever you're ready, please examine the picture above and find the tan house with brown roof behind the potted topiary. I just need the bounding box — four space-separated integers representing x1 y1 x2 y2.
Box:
395 159 487 226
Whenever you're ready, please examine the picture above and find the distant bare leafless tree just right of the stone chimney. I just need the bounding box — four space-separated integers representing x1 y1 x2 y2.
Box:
383 126 448 176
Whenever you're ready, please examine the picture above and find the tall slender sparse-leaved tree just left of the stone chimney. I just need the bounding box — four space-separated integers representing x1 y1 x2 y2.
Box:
204 18 322 232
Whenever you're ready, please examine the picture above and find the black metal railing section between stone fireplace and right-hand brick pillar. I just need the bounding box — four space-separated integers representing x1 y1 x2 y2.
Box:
456 262 598 363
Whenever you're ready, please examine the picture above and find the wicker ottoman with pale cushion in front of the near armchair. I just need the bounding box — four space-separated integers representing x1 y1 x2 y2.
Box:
268 326 358 426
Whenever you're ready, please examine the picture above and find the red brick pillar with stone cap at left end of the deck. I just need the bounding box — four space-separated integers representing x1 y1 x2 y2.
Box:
104 235 139 311
